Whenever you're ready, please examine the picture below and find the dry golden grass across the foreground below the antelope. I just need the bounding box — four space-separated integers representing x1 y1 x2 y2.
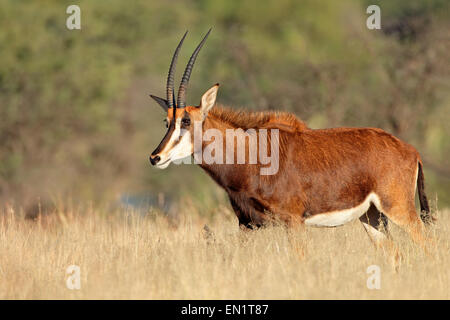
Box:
0 205 450 299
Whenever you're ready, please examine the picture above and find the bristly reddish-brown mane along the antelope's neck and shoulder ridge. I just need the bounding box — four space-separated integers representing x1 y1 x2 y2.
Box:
208 105 308 132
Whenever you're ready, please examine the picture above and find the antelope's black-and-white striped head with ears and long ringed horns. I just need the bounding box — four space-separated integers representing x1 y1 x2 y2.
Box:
150 29 219 169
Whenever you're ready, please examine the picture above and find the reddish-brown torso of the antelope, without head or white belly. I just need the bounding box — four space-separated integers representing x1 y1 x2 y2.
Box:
200 107 428 231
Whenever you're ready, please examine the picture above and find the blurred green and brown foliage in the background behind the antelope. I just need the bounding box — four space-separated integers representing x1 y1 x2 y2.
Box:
0 0 450 205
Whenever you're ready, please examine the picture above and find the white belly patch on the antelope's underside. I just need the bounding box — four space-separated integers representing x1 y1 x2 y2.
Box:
305 192 381 227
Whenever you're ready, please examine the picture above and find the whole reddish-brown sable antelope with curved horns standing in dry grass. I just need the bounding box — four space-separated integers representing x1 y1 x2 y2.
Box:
150 30 431 248
